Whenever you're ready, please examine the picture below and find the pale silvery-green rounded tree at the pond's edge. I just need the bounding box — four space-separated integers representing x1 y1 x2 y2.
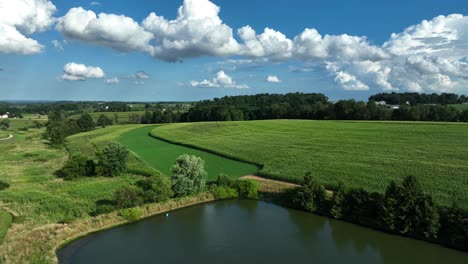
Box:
171 154 206 197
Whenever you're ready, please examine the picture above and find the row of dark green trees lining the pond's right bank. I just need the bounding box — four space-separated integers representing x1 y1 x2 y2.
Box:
290 174 468 251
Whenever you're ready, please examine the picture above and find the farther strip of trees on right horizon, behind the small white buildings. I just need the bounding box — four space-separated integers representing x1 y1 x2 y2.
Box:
369 93 468 105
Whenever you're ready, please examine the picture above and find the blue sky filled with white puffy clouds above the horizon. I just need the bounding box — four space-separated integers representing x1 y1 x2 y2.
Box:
0 0 468 101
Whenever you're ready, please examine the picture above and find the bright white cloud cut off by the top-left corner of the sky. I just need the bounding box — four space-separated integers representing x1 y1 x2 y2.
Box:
0 0 56 55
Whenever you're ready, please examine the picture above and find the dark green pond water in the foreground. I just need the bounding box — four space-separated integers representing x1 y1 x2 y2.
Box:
58 200 468 264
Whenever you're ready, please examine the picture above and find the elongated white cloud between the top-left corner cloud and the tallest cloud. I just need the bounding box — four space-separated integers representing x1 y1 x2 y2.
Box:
56 7 153 52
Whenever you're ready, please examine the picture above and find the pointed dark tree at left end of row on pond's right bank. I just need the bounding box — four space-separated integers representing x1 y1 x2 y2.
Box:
294 173 326 212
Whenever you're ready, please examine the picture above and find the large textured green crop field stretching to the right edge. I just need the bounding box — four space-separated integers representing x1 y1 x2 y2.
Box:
151 120 468 208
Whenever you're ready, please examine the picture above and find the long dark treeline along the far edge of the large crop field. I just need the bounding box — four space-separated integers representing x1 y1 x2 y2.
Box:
181 93 468 122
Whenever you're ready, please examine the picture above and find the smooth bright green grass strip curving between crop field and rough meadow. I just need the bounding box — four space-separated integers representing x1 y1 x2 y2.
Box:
118 126 257 180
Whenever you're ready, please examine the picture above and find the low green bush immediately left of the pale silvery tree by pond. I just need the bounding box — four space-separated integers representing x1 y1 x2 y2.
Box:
136 176 172 203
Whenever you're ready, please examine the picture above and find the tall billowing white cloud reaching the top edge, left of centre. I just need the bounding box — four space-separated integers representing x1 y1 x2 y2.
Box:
142 0 239 61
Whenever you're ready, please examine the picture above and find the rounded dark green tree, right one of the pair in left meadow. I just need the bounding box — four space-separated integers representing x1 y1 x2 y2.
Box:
96 143 128 177
